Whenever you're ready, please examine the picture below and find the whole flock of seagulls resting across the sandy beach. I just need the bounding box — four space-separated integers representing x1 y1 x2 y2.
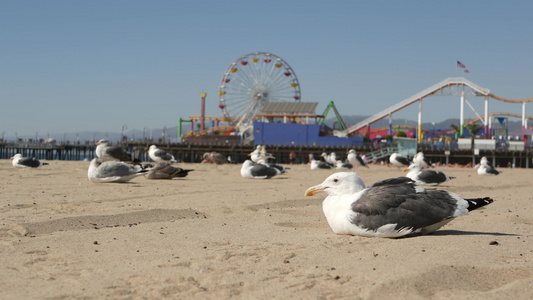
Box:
8 144 501 238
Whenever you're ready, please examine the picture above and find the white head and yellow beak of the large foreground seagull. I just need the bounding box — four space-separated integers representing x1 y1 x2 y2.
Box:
305 172 365 196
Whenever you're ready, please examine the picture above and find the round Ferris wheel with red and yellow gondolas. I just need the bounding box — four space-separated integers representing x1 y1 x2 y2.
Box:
218 52 300 127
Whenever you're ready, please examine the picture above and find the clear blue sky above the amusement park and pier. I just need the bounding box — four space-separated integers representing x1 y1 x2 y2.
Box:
0 0 533 137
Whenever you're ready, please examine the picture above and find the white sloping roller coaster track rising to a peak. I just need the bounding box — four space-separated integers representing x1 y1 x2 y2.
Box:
342 77 533 135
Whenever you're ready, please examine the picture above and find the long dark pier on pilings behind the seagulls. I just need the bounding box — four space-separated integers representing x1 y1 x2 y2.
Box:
0 142 533 168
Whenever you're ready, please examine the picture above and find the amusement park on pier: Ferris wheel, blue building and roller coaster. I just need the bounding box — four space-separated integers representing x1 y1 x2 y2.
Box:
178 52 533 146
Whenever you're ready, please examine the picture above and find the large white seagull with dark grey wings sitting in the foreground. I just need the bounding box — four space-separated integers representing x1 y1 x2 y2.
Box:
305 172 494 238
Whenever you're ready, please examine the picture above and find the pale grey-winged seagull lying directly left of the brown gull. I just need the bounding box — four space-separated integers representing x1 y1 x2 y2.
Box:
87 158 147 182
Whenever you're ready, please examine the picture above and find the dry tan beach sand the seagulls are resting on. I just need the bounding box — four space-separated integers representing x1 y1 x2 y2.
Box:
0 160 533 299
